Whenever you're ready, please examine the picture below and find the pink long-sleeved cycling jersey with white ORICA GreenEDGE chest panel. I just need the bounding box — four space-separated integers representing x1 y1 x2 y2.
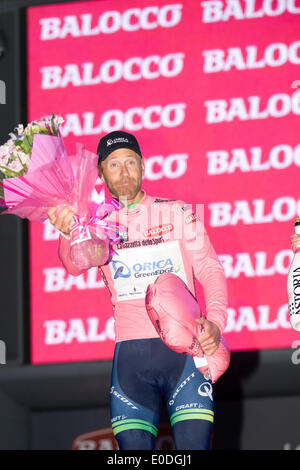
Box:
59 190 227 342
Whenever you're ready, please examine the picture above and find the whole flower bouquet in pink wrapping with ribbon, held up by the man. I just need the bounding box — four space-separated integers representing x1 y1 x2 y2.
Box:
0 114 120 268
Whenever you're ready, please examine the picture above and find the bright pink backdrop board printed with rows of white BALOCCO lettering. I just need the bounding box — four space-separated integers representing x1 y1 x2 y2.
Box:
27 0 300 364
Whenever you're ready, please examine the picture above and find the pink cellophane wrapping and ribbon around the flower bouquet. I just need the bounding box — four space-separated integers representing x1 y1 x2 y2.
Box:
2 134 120 269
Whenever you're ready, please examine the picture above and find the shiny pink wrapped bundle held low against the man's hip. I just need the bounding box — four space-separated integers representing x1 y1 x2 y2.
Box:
145 273 230 383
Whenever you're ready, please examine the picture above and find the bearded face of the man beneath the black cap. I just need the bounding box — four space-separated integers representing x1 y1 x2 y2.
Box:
99 148 145 200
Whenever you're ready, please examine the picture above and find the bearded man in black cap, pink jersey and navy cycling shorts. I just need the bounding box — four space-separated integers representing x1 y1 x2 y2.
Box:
48 131 227 450
